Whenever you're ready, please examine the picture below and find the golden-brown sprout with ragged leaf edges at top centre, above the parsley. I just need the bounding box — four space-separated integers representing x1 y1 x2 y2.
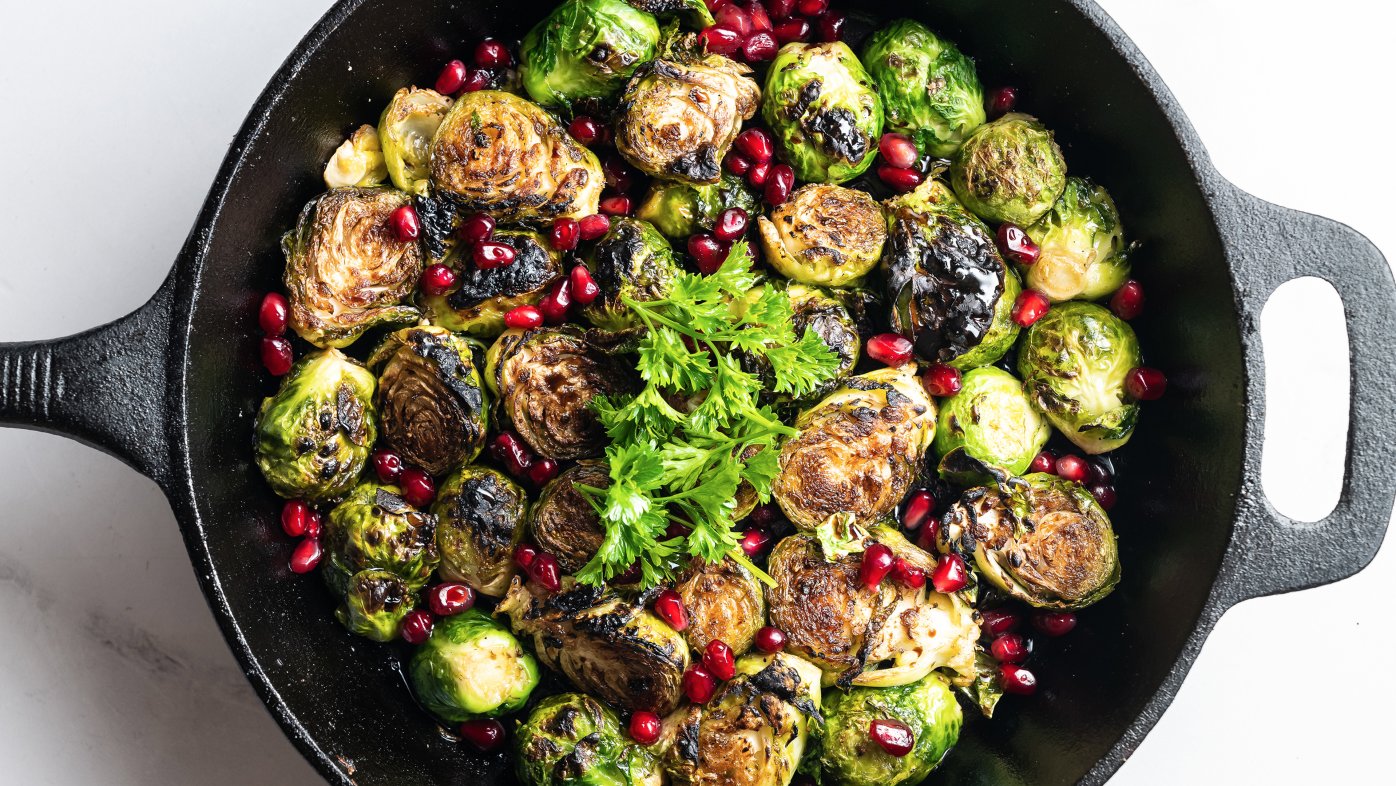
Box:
616 54 761 183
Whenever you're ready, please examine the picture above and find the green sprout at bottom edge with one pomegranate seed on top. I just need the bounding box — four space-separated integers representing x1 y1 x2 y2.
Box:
819 674 963 786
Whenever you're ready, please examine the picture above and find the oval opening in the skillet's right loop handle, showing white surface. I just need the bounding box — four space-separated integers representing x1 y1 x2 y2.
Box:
1261 276 1351 522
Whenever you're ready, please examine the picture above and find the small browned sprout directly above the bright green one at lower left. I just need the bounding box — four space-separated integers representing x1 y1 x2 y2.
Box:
431 466 528 598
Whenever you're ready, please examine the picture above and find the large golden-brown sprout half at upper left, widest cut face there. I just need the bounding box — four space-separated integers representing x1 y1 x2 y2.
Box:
430 91 606 221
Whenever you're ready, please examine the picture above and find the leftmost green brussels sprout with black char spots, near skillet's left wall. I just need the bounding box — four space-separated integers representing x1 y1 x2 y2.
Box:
253 349 378 503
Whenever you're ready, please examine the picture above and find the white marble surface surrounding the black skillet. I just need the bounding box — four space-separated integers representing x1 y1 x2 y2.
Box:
0 0 1396 786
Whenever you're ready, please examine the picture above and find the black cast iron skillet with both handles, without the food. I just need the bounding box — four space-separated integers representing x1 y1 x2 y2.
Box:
0 0 1396 786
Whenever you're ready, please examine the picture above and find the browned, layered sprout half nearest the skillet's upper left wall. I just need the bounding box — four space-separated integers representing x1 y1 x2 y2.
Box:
281 188 422 349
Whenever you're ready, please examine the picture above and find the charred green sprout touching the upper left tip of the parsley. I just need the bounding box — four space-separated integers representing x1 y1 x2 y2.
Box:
581 218 680 331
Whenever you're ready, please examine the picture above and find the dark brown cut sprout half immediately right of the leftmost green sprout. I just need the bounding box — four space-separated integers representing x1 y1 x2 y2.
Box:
369 325 489 475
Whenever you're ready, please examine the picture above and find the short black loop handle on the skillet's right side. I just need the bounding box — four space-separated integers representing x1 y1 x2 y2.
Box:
1215 183 1396 603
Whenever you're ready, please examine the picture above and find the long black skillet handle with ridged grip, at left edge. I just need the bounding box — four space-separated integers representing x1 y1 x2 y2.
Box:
0 271 175 486
